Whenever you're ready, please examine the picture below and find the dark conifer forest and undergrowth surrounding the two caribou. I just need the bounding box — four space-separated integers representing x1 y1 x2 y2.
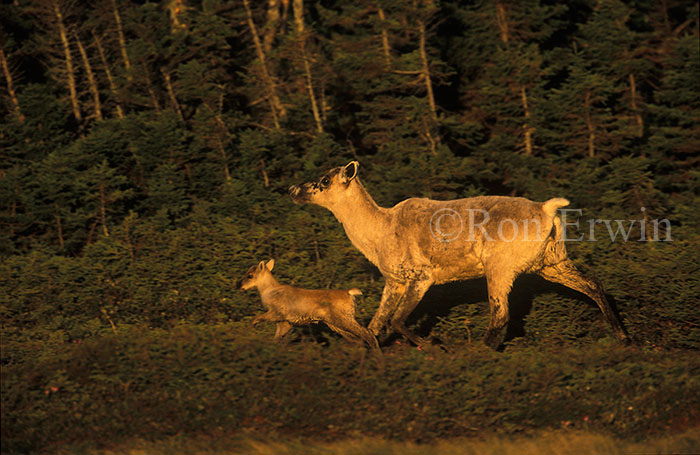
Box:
0 0 700 453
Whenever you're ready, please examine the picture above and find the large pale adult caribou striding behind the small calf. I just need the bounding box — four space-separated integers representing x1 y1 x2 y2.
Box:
289 161 627 348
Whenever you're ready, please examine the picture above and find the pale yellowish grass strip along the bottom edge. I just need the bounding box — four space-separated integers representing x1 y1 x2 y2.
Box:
55 428 700 455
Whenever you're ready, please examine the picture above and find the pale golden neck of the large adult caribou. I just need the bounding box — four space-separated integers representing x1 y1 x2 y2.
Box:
328 178 389 265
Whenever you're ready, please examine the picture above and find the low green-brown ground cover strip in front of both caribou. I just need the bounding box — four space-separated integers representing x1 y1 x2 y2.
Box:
2 323 700 452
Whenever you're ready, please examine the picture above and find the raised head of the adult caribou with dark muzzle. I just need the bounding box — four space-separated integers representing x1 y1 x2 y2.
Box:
289 161 360 209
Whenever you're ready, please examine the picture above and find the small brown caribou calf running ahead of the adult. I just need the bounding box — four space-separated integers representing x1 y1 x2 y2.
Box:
238 259 379 350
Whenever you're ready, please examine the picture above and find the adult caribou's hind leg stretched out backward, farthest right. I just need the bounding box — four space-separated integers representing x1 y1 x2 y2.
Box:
537 259 629 342
